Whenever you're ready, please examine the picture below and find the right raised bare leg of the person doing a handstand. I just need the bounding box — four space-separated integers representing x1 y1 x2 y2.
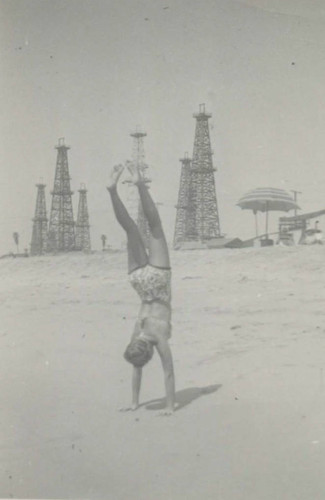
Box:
128 164 170 267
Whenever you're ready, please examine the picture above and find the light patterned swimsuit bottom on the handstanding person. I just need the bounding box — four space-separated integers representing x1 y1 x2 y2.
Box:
129 264 171 304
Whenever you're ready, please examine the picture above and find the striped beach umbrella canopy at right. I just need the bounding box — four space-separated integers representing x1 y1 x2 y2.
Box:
237 188 300 212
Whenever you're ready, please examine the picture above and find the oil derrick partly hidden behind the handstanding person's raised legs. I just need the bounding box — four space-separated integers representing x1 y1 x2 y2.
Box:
126 129 151 247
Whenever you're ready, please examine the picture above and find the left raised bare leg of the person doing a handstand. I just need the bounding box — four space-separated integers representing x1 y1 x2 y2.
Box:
107 165 148 273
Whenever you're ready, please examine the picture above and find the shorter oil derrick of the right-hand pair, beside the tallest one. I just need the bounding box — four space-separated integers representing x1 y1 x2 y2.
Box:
174 153 192 249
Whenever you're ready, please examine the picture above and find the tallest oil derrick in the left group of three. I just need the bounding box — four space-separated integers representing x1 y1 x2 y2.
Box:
47 138 76 252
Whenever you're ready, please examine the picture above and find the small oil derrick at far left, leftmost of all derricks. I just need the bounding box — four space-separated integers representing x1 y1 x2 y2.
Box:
30 182 48 255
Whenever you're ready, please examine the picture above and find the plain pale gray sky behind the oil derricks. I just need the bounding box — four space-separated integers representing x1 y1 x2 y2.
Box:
0 0 325 254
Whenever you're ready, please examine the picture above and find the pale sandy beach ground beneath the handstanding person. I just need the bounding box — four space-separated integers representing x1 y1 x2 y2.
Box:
0 246 325 500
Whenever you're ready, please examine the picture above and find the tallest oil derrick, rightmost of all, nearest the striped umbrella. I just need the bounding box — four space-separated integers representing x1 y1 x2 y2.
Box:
186 104 221 243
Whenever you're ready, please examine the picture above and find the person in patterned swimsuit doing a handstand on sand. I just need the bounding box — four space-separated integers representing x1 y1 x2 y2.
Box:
107 163 175 415
